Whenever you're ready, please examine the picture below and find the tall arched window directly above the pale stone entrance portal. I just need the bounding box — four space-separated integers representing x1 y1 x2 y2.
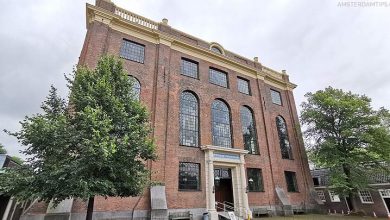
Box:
211 99 232 148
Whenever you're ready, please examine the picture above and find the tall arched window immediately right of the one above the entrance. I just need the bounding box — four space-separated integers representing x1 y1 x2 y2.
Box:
240 106 259 154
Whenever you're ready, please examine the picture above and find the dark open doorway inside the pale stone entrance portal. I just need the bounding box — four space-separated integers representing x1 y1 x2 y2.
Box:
214 168 234 211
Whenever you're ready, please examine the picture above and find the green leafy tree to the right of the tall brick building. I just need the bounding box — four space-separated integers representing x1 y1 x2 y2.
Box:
301 87 390 209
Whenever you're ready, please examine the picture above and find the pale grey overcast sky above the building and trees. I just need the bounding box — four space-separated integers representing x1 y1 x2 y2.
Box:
0 0 390 156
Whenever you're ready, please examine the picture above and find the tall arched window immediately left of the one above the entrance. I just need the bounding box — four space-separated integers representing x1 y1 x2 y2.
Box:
180 92 199 147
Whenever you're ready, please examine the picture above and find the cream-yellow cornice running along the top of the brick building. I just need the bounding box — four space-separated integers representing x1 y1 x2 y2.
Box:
86 4 296 90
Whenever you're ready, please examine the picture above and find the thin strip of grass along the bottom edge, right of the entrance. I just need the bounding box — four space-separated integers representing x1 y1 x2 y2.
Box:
255 214 387 220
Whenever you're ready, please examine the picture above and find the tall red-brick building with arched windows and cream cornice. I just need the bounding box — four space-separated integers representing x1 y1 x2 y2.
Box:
20 0 317 219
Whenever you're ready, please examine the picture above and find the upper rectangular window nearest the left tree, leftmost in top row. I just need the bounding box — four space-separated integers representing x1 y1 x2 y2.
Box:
120 40 145 63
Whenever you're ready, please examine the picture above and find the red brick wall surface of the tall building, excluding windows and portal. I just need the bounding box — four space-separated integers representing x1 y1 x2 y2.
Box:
25 3 312 215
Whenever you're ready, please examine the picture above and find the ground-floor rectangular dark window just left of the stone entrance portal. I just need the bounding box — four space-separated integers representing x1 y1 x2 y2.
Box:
179 162 200 190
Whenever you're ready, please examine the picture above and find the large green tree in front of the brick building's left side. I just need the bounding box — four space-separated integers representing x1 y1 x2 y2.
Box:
0 57 156 219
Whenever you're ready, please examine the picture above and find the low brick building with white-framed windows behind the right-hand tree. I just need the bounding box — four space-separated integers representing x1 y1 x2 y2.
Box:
311 169 390 217
